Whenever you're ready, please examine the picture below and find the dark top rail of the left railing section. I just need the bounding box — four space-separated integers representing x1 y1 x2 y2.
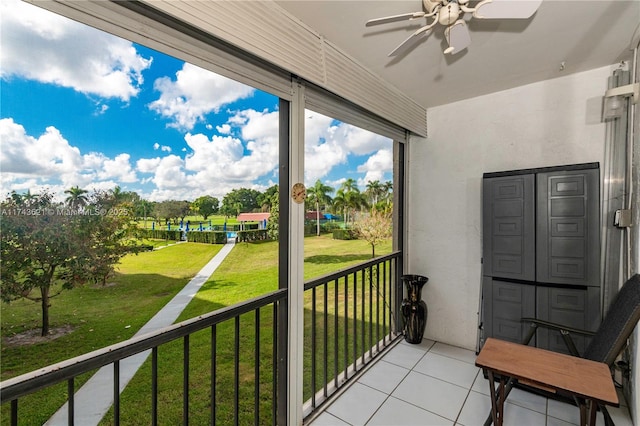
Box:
0 289 287 404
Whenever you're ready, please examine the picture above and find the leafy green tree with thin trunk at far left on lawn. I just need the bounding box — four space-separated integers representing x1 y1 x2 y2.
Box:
0 192 140 336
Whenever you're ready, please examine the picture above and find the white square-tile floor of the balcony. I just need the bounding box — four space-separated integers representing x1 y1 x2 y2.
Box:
310 340 632 426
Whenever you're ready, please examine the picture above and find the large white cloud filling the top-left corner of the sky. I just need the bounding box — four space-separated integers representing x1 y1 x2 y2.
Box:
0 0 152 101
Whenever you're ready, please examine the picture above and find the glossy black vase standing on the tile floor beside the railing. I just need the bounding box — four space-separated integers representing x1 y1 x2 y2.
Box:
400 275 429 343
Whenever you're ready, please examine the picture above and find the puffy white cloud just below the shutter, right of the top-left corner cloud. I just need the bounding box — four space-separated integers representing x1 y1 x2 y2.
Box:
149 63 254 130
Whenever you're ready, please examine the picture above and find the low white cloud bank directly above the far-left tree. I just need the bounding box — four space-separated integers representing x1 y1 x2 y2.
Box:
0 118 137 192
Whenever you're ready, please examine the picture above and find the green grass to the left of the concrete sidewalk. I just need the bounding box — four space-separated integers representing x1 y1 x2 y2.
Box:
1 243 221 424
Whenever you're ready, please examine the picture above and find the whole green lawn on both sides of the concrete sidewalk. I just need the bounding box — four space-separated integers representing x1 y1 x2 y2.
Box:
2 236 391 424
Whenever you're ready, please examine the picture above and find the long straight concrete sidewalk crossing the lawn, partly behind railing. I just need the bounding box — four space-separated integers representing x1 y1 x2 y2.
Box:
45 239 235 426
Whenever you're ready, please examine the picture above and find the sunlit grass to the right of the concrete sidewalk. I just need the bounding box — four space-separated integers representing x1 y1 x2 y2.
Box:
107 236 391 425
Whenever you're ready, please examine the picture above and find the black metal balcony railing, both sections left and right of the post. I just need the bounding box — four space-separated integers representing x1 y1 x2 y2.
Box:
0 252 402 425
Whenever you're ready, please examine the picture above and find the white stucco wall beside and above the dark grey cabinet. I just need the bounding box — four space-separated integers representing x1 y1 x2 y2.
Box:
405 67 612 349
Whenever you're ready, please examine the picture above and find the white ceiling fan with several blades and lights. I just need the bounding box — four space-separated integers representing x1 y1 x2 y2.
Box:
366 0 542 56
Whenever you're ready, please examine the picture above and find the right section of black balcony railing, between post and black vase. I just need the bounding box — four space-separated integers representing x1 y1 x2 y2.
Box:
303 252 402 417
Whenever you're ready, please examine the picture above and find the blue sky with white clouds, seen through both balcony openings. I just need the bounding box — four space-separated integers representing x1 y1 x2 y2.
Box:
0 0 392 201
